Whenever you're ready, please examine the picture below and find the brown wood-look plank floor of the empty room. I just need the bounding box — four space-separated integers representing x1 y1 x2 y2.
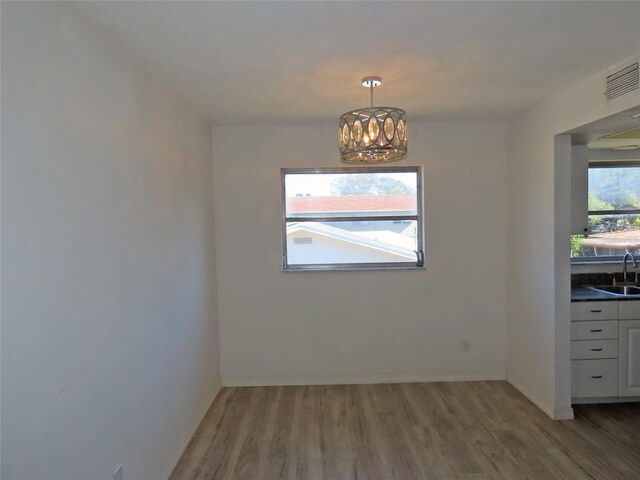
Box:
171 382 640 480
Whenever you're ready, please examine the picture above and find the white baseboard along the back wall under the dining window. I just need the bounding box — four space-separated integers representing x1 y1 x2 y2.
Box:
222 372 506 387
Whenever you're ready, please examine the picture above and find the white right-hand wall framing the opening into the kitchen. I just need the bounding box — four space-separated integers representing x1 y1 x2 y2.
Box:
507 54 640 418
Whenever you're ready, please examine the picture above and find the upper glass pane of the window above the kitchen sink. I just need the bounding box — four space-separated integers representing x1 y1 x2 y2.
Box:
589 167 640 211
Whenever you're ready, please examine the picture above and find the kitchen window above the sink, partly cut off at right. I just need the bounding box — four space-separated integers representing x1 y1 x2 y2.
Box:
571 162 640 261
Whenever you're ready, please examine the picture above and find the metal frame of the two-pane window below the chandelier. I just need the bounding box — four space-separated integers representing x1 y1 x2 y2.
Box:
280 166 424 272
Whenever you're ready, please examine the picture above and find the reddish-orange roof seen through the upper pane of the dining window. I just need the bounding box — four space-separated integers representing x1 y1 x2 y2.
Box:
287 194 417 215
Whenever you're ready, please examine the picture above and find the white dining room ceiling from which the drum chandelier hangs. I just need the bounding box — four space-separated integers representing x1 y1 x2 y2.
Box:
75 1 640 125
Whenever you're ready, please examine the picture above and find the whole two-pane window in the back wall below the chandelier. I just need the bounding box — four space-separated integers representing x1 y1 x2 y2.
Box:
282 167 424 271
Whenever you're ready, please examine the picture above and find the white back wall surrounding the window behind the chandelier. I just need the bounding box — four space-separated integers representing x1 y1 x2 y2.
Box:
213 122 506 385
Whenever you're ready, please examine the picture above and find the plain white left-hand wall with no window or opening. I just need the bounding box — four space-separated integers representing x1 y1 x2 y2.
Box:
1 2 220 480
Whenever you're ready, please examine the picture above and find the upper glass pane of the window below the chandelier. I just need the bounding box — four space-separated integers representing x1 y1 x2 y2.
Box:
285 172 417 218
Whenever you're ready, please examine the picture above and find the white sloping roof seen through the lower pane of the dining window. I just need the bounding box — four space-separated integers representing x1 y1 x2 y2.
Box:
287 223 416 260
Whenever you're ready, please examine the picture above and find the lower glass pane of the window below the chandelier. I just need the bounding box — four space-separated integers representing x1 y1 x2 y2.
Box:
286 220 417 265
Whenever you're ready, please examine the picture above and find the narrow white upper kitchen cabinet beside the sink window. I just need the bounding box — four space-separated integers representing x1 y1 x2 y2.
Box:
571 145 589 234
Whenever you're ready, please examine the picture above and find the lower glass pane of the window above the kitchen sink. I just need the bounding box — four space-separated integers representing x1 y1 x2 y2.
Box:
571 214 640 257
